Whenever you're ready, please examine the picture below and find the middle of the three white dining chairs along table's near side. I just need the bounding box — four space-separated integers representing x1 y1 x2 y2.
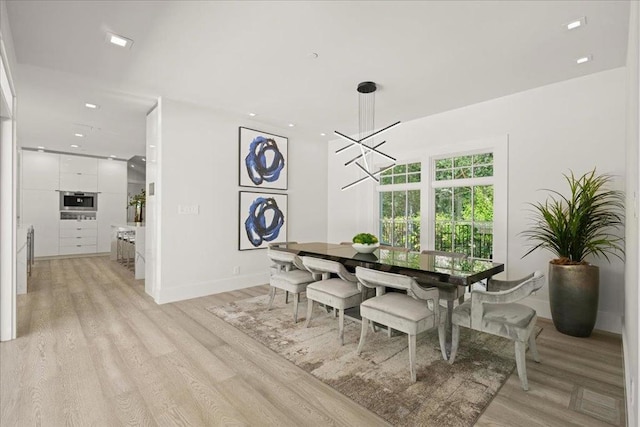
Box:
301 256 363 345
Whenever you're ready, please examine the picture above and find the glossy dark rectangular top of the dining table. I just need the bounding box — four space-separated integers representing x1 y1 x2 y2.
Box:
271 242 504 286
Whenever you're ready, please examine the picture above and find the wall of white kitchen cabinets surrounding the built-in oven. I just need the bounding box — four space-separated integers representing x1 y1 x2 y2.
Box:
20 150 127 257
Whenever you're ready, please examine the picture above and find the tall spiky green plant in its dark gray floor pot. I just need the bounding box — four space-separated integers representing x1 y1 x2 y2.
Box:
521 169 624 337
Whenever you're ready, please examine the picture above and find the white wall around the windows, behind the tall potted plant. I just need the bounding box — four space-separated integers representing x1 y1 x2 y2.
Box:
328 68 625 332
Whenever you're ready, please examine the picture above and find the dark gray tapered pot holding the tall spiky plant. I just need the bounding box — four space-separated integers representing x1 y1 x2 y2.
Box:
549 263 600 337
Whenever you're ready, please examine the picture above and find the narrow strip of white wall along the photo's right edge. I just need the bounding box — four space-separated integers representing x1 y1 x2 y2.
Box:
622 2 640 426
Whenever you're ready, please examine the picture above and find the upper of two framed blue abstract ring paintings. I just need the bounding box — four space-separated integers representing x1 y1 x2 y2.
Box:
239 127 288 190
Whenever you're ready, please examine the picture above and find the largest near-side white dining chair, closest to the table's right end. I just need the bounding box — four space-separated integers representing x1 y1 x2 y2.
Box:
356 267 446 382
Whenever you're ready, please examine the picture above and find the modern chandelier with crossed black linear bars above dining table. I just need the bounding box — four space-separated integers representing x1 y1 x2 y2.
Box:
334 82 400 190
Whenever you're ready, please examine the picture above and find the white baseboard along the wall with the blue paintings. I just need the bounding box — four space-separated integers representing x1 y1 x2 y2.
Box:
155 271 269 304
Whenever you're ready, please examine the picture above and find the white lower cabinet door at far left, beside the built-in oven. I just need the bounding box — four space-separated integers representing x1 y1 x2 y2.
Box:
21 189 60 257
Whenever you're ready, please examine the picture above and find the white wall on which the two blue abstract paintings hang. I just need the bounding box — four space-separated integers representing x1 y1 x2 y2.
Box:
152 98 327 303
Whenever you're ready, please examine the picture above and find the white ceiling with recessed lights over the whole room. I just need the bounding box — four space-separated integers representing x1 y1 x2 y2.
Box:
3 1 629 158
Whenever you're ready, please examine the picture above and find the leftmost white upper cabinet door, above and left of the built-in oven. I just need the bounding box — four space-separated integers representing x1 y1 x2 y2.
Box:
22 150 60 190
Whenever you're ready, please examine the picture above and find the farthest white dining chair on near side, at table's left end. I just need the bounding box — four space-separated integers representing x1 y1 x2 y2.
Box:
267 248 315 323
